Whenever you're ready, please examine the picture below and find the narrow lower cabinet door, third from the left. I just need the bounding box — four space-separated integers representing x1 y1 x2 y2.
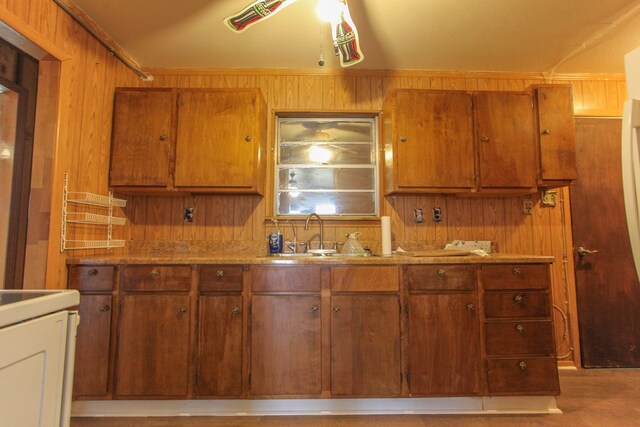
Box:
196 295 242 397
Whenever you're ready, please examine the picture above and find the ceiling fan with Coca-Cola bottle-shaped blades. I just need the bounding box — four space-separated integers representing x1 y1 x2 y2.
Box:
224 0 364 67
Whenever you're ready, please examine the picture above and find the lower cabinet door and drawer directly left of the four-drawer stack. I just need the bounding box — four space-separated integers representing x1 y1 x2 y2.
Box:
404 265 482 396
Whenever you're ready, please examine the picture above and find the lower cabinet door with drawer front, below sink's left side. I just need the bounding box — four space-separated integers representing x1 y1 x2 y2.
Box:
250 266 322 397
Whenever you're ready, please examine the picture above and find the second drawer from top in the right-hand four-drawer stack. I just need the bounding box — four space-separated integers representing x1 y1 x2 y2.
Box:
484 291 551 318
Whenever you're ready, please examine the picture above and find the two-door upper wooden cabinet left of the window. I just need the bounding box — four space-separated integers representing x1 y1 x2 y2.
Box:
110 89 267 194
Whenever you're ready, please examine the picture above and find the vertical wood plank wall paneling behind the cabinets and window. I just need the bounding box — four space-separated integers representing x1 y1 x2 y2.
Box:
5 0 626 364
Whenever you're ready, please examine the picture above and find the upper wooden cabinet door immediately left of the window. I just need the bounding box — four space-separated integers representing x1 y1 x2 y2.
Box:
175 91 261 188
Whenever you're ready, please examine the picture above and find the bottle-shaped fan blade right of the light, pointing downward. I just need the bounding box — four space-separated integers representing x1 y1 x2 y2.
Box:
331 0 364 67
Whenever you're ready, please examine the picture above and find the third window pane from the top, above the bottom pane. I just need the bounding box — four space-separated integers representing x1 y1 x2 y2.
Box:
278 168 375 190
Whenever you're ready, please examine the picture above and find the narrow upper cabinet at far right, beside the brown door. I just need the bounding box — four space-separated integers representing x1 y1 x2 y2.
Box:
532 85 577 187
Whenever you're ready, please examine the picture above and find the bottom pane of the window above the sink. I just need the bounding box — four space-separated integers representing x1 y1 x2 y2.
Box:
278 192 376 215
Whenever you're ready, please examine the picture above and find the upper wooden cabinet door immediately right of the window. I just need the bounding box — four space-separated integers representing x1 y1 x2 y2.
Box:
394 91 475 188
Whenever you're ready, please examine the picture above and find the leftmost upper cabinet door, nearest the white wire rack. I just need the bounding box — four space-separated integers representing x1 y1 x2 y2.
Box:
109 90 173 187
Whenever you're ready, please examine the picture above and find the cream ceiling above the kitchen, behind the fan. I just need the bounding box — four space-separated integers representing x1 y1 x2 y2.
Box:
73 0 640 73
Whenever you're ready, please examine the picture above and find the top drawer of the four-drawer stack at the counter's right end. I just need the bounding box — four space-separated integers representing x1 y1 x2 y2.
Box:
480 264 549 289
